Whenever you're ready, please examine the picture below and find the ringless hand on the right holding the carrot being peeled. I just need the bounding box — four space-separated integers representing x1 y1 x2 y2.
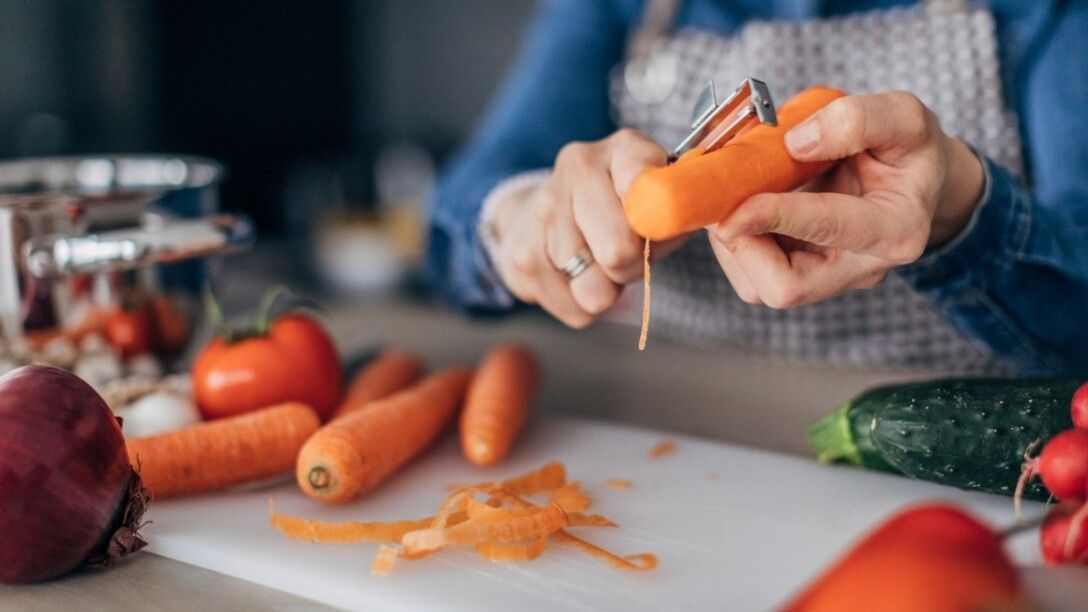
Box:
709 91 985 308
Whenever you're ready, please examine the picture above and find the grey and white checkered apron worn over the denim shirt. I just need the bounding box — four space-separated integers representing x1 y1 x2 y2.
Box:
613 0 1023 374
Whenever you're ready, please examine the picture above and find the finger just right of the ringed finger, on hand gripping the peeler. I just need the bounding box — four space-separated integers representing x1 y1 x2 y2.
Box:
571 174 642 284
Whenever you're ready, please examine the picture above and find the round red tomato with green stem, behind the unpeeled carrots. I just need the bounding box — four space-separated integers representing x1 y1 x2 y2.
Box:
193 315 341 420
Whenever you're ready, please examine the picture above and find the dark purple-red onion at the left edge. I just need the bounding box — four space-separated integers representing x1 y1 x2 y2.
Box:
0 366 146 583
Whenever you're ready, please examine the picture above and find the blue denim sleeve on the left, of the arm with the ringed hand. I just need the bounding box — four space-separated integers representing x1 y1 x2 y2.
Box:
426 0 630 313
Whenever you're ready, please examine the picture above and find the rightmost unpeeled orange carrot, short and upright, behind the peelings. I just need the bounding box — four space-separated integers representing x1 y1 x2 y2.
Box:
461 344 540 466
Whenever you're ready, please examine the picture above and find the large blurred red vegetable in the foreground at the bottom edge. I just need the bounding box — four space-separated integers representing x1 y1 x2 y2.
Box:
784 504 1024 612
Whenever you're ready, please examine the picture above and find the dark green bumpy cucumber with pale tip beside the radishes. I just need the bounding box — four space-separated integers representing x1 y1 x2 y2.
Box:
808 378 1079 500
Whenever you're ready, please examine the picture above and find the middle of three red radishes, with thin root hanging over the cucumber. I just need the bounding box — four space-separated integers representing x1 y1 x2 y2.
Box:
1014 429 1088 516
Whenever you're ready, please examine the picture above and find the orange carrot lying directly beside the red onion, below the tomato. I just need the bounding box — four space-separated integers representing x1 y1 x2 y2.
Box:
126 402 321 499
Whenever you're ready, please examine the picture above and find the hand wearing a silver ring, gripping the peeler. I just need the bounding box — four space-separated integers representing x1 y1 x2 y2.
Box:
492 130 679 328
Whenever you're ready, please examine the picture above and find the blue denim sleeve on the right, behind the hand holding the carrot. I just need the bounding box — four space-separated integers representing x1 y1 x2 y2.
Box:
899 155 1088 376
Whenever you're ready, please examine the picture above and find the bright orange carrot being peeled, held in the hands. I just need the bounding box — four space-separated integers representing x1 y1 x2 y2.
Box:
623 87 845 241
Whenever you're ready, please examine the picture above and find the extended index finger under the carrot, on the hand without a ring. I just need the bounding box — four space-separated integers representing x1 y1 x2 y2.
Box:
715 192 929 259
